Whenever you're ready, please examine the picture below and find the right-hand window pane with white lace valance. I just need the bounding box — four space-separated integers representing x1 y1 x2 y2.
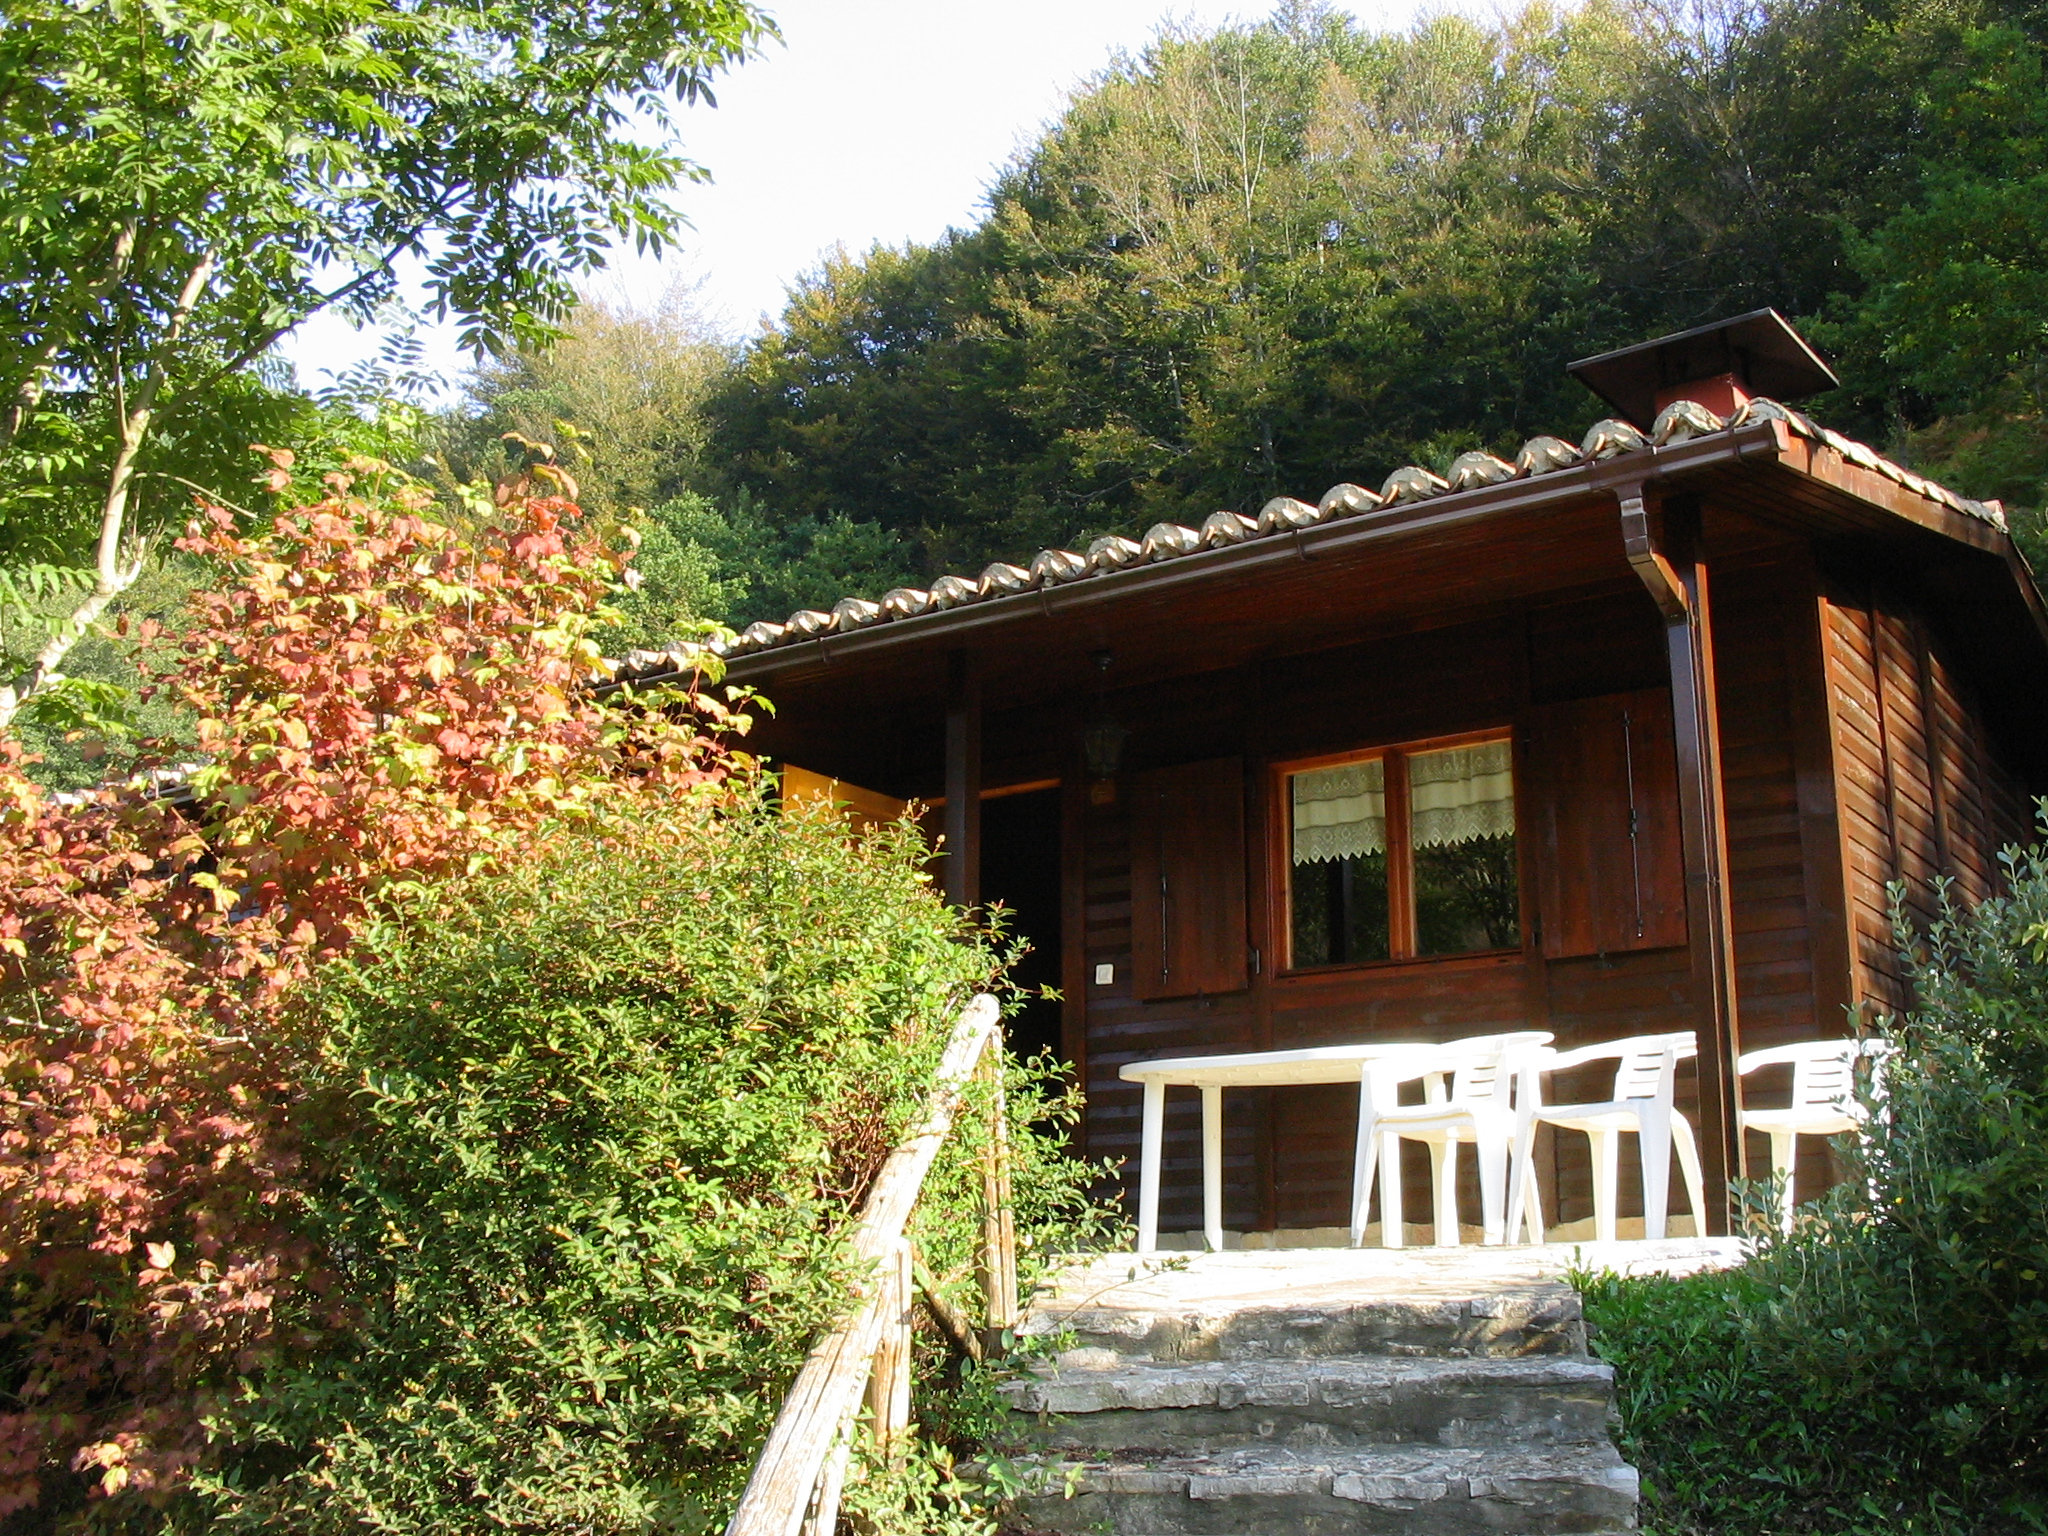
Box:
1407 741 1522 954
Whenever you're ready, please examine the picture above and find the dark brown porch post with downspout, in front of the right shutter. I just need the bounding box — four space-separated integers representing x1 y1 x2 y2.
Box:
1618 493 1747 1235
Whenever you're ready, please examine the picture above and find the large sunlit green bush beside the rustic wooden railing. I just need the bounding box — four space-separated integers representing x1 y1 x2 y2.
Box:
188 797 1094 1536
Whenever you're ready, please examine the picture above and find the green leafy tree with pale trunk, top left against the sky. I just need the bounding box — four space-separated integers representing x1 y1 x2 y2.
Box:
0 0 768 719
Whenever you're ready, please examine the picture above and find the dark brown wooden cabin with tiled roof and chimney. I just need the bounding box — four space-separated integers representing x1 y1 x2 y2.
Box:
622 311 2048 1243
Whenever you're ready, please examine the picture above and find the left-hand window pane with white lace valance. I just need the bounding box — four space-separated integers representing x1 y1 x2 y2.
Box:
1288 758 1391 965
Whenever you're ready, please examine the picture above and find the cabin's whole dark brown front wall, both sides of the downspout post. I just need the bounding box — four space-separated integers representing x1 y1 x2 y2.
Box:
1071 549 1851 1231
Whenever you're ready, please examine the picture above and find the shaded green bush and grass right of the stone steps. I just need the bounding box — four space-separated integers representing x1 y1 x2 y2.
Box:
1585 823 2048 1532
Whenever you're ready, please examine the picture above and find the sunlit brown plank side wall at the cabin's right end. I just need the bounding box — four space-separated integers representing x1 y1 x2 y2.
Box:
1821 563 2032 1022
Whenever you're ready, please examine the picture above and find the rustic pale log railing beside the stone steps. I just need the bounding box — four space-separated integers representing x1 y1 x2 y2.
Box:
725 995 1018 1536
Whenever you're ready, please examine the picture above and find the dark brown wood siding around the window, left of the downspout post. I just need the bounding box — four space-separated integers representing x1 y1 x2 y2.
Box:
1075 586 1692 1231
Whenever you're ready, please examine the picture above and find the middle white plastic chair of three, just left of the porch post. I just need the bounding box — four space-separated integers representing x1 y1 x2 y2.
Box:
1507 1030 1706 1243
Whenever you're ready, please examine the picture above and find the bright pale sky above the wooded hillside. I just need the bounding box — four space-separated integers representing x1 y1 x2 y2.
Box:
283 0 1417 397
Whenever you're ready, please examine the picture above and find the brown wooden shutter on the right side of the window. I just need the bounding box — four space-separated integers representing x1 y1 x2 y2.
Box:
1530 688 1686 958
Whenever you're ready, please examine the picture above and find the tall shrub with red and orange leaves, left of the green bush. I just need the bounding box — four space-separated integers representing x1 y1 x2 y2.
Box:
0 483 741 1516
